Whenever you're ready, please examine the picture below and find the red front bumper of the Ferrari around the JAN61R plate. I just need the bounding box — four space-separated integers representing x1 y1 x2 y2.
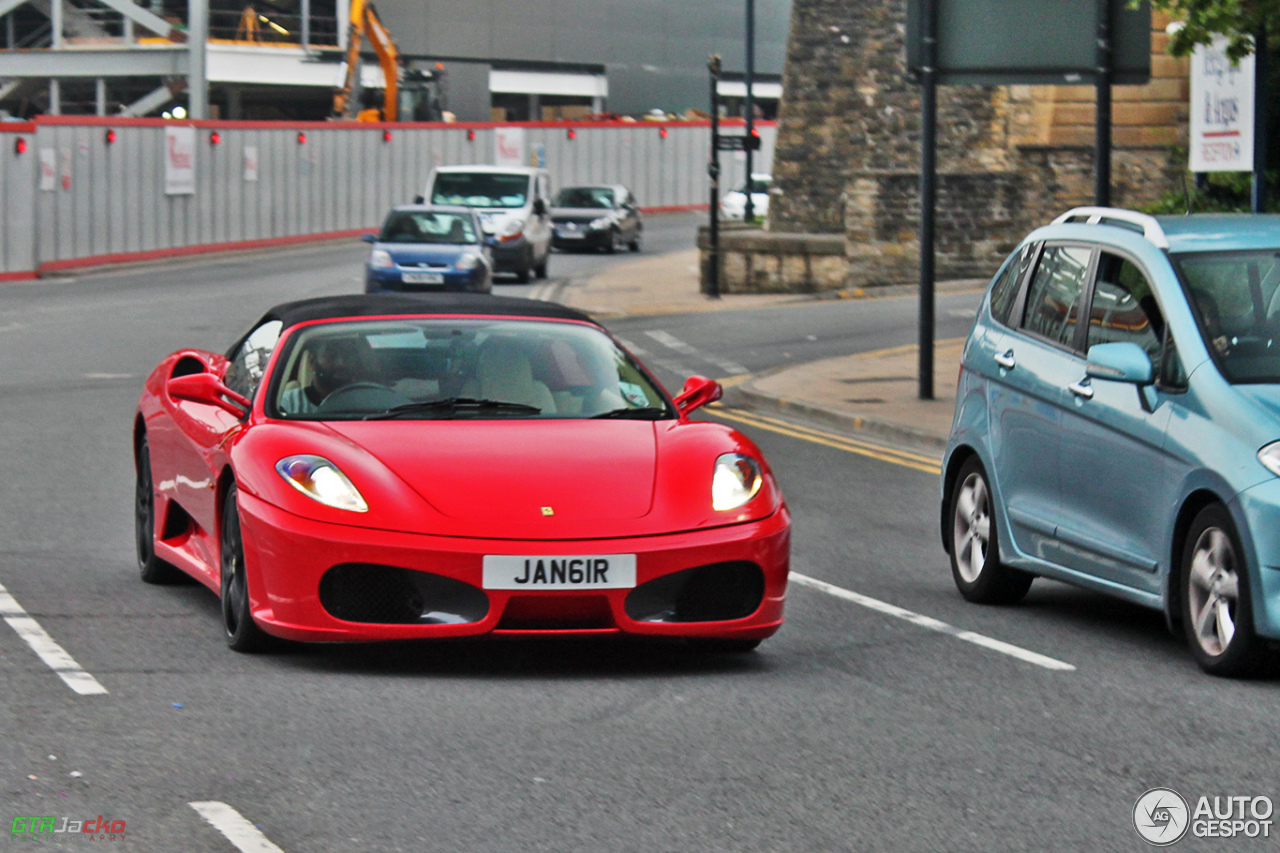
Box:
239 492 791 642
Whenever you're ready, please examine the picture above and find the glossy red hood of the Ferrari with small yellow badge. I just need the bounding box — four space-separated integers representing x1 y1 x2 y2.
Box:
328 419 657 517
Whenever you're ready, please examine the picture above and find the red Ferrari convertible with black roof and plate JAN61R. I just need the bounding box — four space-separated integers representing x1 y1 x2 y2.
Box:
133 295 790 651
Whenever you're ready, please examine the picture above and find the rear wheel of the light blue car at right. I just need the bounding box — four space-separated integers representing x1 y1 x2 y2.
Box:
948 456 1034 605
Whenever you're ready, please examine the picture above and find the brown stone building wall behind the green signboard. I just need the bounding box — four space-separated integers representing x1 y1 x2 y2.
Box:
767 0 1187 287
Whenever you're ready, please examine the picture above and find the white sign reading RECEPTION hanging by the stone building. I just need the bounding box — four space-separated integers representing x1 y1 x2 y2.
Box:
1190 37 1253 172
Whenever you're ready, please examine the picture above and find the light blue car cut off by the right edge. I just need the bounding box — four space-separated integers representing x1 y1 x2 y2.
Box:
942 207 1280 675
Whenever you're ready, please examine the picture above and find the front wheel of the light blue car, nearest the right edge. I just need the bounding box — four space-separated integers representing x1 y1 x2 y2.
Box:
1180 503 1263 676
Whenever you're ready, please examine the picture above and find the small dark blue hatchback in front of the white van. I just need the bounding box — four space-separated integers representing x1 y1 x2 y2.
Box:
365 205 493 293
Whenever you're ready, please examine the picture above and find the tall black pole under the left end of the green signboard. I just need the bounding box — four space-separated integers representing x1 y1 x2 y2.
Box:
920 0 938 400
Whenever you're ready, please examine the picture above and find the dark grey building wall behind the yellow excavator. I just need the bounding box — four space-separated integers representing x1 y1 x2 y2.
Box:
378 0 791 118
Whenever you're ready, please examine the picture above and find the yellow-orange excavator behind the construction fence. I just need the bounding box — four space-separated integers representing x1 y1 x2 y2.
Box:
333 0 439 122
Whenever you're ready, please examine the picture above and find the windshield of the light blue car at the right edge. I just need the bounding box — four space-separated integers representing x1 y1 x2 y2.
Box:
1174 251 1280 383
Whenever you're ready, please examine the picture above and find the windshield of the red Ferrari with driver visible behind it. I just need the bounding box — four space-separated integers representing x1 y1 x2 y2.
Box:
268 318 676 420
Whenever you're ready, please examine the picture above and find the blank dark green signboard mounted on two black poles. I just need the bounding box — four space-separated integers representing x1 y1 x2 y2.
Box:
906 0 1151 86
